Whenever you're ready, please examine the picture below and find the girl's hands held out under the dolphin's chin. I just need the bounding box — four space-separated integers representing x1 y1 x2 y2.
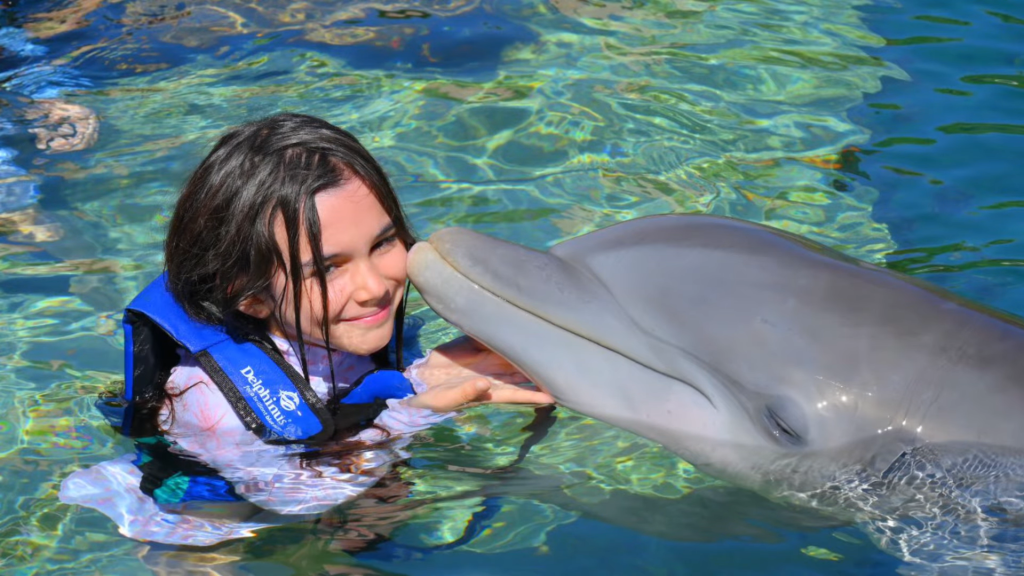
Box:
403 337 554 412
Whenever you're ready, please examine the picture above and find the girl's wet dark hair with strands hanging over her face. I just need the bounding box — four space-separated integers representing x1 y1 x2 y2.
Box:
138 114 415 434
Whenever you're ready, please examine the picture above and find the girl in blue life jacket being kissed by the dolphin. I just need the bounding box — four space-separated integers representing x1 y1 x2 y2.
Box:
60 114 552 545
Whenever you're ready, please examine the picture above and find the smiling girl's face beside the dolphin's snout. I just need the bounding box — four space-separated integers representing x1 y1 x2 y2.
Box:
249 177 407 356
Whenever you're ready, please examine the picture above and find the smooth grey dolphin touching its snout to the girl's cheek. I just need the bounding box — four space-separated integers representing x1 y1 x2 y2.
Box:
409 214 1024 573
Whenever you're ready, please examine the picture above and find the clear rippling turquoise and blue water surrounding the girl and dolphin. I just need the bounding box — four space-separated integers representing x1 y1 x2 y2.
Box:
0 0 1024 575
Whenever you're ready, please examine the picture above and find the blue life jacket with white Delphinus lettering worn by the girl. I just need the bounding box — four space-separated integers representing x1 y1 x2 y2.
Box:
121 273 414 444
